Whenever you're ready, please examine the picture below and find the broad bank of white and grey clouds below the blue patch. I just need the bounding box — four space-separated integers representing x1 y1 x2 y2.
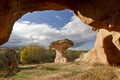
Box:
4 15 96 49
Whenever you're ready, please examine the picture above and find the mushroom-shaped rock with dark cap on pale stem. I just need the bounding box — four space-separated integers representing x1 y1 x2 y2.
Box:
49 39 74 63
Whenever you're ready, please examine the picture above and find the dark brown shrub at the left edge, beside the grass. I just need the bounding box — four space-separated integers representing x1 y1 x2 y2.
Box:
0 49 19 77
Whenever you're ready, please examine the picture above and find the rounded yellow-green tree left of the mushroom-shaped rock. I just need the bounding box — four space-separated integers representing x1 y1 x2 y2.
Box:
20 44 46 64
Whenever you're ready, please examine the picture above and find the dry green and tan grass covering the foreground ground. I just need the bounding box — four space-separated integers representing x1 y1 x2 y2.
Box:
0 62 120 80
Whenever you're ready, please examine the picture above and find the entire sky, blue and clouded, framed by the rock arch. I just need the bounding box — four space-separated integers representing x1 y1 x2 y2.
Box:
2 9 96 50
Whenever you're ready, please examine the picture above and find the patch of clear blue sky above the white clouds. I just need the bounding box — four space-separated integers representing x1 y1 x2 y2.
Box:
18 9 74 29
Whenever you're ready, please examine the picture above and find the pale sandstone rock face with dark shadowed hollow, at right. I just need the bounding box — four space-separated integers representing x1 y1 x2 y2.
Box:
83 29 120 65
